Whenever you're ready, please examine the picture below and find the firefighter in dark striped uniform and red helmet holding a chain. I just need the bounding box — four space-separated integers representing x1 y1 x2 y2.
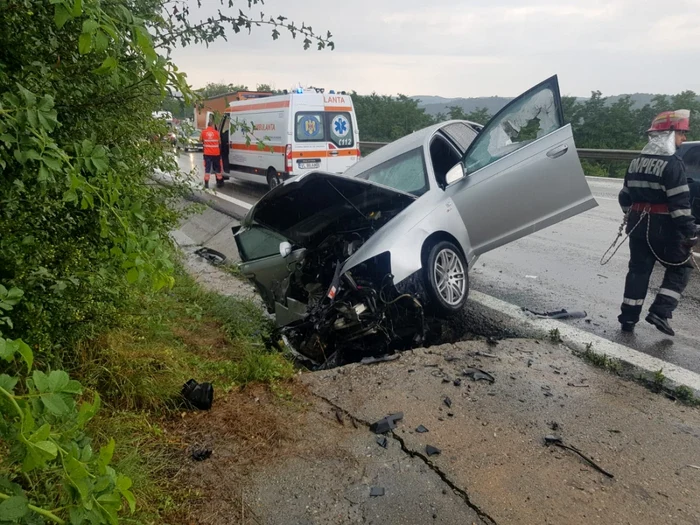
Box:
618 110 697 336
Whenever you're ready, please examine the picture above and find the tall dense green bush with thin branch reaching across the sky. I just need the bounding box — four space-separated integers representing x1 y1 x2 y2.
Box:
0 0 333 362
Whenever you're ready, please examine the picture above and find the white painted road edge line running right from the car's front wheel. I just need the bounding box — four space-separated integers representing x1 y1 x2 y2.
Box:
469 291 700 395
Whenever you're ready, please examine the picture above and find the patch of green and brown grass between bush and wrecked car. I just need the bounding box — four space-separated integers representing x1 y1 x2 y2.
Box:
73 264 294 523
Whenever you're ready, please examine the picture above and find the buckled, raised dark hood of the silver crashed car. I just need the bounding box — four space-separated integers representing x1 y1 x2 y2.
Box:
241 172 417 249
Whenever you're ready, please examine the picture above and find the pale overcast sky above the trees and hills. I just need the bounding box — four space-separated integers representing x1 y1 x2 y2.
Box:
174 0 700 97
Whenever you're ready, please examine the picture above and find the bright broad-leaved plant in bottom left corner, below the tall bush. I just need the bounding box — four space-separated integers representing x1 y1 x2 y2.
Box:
0 287 136 524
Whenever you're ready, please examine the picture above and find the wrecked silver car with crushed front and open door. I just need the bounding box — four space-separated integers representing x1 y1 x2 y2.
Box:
234 76 597 366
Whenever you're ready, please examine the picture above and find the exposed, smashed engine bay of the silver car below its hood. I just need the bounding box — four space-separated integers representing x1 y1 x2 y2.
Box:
282 229 426 368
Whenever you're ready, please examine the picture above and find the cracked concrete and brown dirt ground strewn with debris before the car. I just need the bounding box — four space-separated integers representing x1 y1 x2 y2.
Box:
173 247 700 525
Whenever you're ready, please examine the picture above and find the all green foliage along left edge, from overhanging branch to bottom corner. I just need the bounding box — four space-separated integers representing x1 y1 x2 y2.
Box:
0 0 333 524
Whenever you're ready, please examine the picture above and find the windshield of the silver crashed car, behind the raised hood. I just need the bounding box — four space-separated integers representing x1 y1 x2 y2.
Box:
356 148 428 197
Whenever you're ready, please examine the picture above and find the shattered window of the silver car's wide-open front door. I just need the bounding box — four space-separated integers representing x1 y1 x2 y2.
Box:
464 77 564 174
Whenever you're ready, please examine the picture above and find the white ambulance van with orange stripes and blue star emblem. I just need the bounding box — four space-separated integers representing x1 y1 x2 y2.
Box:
219 88 360 188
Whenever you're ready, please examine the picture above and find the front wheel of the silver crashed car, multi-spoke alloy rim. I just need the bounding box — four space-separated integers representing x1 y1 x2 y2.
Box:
423 241 469 316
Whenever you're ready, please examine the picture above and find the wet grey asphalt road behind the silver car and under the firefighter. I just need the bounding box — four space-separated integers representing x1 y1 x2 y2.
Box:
179 153 700 373
